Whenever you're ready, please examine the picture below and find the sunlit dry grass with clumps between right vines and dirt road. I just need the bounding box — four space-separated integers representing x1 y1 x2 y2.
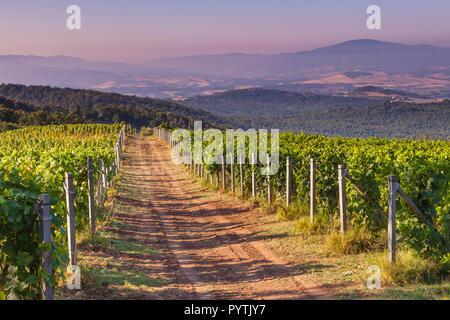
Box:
183 164 450 299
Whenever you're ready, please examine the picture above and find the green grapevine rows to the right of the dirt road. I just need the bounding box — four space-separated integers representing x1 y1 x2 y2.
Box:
154 128 450 264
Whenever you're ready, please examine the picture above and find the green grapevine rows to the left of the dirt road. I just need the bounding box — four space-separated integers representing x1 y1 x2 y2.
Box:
0 124 123 300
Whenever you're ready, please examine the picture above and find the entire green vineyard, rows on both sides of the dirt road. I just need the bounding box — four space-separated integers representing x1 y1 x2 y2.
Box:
0 124 450 299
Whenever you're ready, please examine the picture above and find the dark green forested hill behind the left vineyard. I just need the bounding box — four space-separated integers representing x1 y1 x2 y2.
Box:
0 84 227 128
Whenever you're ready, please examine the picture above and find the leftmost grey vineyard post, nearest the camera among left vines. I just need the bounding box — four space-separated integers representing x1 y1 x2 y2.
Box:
37 194 54 300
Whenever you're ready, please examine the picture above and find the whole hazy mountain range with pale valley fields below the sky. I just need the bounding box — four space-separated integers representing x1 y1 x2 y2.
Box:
0 40 450 98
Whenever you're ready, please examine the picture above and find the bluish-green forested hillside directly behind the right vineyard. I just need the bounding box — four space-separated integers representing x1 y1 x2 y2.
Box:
225 100 450 139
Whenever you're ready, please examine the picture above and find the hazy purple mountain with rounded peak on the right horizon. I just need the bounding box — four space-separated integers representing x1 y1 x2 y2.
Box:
150 39 450 79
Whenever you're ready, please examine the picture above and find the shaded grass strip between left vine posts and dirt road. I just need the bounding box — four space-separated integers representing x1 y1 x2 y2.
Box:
55 160 169 299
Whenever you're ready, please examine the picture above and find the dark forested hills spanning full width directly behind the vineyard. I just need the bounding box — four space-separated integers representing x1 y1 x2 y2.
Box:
0 85 450 139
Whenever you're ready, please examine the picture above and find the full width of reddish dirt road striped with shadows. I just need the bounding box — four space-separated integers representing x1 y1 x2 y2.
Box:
69 137 327 299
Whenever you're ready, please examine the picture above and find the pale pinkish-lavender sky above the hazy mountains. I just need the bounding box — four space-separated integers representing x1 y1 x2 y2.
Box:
0 0 450 62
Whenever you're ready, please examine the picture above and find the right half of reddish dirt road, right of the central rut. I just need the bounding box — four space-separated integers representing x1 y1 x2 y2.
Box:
134 137 328 299
